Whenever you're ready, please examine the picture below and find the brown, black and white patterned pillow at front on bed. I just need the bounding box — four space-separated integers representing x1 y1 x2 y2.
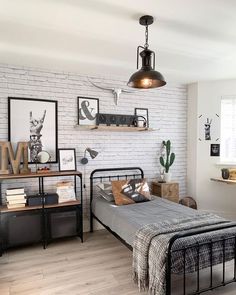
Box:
112 178 151 205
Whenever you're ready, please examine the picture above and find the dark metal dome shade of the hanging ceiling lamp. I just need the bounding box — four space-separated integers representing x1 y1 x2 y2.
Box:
128 68 166 89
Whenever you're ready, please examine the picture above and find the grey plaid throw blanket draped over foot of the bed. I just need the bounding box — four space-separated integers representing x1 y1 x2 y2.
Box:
133 213 236 295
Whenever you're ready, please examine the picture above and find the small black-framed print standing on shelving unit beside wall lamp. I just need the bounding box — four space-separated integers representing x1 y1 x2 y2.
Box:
58 149 76 171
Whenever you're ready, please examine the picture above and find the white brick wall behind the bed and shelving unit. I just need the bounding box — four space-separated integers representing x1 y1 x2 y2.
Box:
0 65 187 215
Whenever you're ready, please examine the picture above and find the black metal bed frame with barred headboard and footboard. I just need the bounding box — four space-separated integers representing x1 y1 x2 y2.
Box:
90 167 236 295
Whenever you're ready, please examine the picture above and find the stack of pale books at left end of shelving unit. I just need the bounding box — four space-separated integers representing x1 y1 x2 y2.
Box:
6 187 26 209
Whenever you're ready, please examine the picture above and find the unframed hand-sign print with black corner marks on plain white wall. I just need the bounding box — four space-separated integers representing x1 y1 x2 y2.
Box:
198 114 220 141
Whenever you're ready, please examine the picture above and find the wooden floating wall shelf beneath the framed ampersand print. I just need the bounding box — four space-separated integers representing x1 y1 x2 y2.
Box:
75 125 154 132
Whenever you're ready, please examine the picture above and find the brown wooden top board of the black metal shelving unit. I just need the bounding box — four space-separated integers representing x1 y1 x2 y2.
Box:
0 171 82 181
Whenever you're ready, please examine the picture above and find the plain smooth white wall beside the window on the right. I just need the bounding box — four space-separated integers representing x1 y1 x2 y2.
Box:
188 80 236 219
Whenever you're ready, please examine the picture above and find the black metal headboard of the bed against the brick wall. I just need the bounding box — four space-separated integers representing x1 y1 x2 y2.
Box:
90 167 144 210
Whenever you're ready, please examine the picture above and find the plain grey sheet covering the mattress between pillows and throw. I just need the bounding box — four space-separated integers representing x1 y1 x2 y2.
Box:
92 196 202 246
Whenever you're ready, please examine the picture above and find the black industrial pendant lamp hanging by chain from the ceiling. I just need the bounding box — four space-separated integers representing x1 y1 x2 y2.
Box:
127 15 166 89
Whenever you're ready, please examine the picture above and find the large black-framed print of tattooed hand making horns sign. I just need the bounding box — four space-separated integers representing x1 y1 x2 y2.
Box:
8 97 58 163
